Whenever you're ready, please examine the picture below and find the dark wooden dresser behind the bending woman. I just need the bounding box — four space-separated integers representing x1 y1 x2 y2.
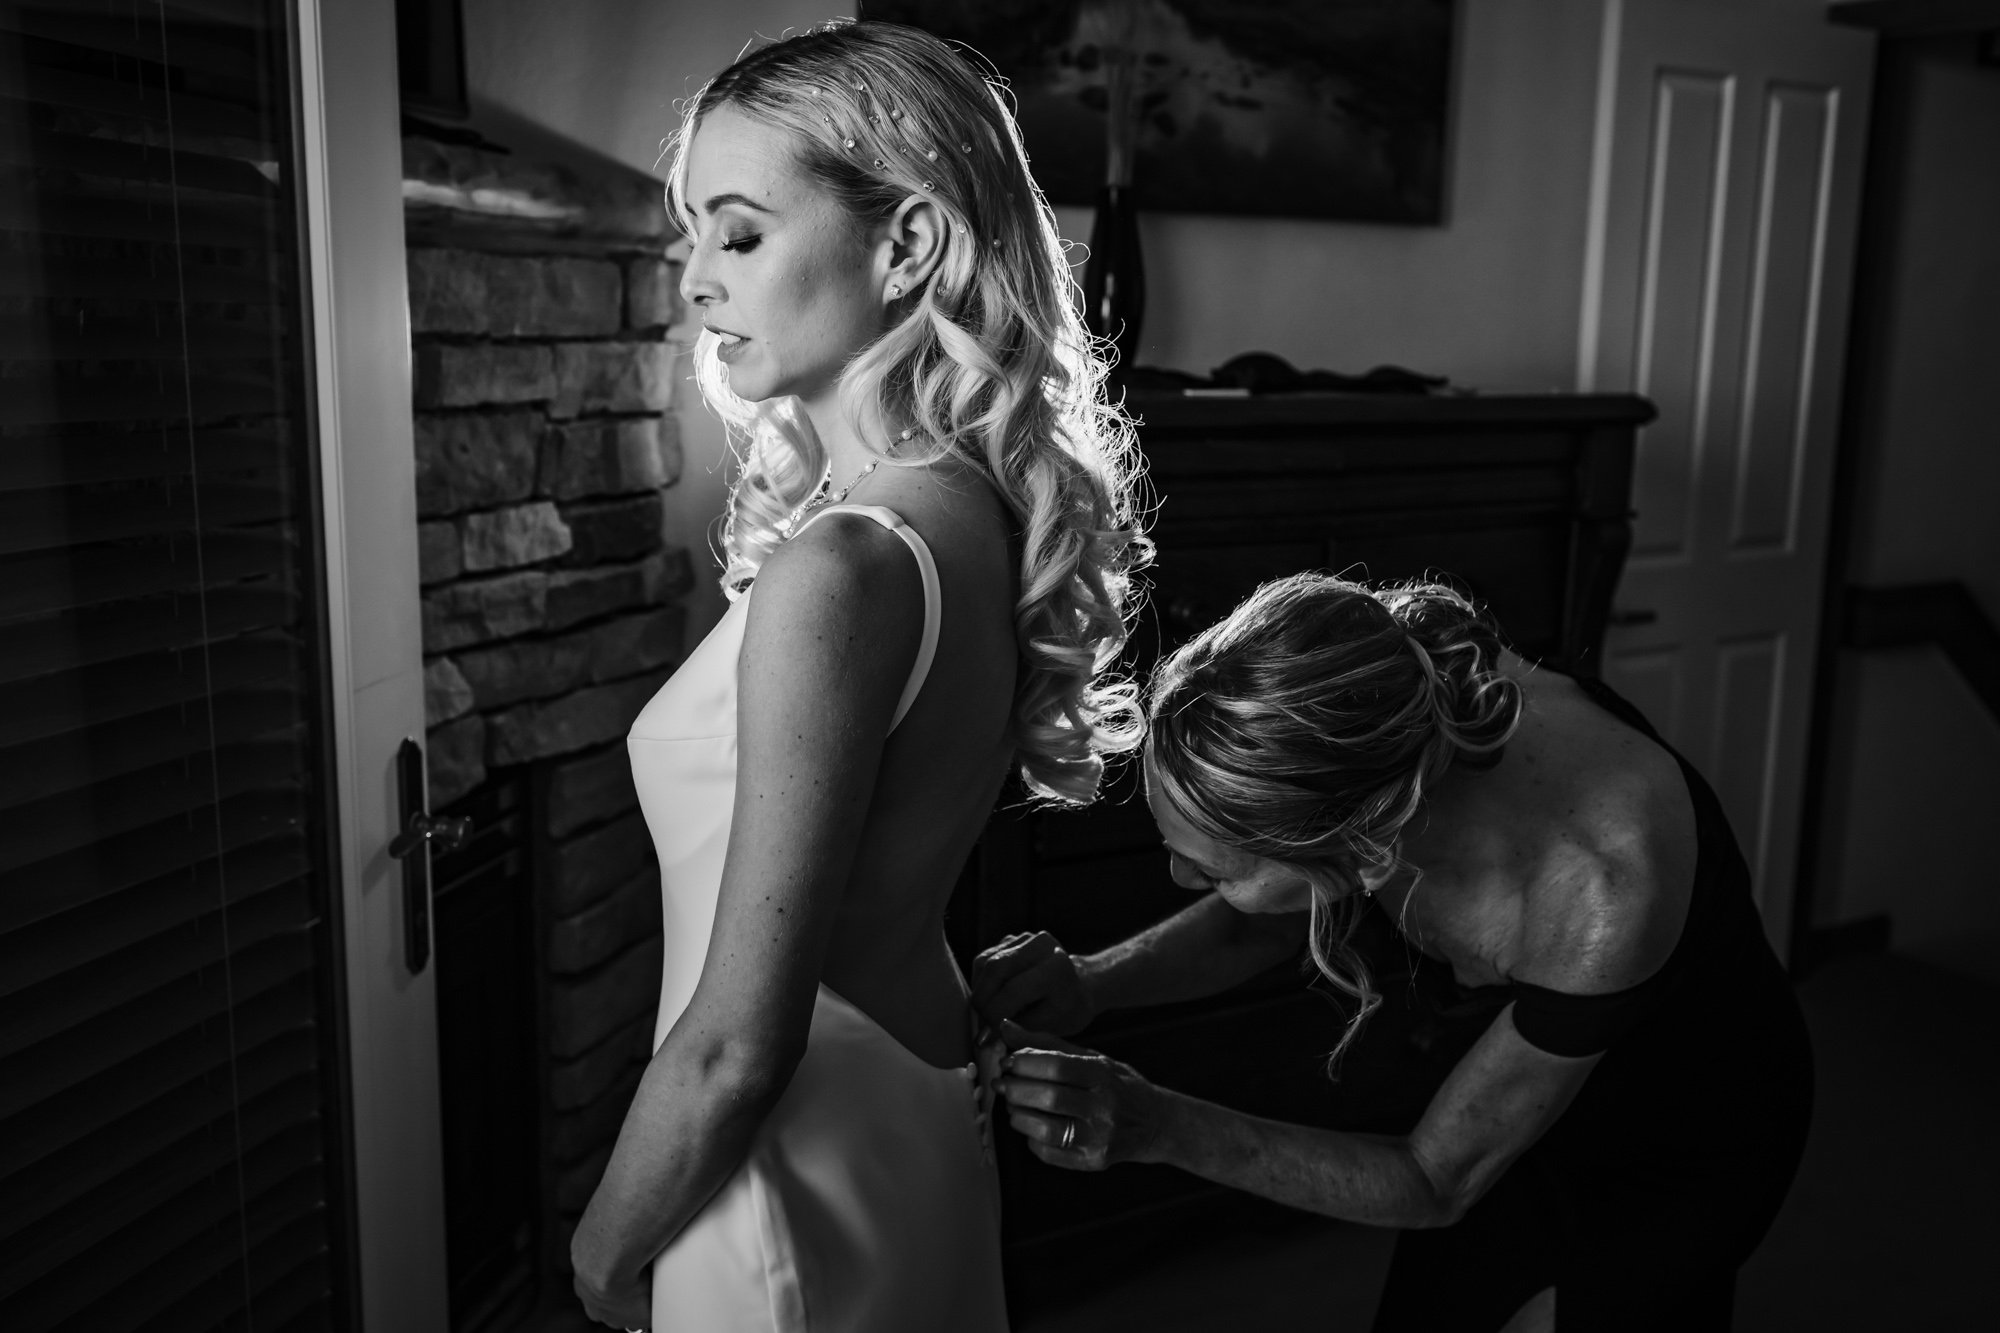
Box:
948 384 1652 1317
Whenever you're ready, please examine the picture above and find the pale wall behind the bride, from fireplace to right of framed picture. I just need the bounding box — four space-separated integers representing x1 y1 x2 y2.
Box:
464 0 1602 634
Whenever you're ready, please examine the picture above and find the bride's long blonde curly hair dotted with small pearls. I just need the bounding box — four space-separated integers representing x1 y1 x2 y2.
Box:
668 20 1152 805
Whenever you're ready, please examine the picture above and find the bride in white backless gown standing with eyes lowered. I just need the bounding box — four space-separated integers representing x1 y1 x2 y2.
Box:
572 22 1148 1333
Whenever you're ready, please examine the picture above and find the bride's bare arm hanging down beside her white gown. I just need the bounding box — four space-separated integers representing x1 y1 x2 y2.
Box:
572 514 924 1313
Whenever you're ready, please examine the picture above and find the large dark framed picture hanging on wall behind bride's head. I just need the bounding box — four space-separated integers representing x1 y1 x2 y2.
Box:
862 0 1452 224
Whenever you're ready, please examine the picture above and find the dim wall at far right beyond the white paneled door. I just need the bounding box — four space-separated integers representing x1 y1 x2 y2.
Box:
1818 38 2000 979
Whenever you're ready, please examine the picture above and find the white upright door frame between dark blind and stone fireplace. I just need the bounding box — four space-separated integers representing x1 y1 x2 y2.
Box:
294 0 448 1333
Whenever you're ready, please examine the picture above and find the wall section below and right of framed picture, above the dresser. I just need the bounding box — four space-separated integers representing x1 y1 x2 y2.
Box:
1104 0 1602 388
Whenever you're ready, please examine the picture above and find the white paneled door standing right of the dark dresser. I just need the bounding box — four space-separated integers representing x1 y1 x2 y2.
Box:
1578 0 1874 955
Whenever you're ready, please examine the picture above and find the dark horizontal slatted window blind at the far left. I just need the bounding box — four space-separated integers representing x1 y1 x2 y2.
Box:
0 0 350 1331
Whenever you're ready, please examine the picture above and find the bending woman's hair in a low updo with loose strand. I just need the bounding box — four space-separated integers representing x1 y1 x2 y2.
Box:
1146 574 1522 1067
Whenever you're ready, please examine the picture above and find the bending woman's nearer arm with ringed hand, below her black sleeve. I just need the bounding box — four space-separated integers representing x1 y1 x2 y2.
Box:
998 1005 1598 1227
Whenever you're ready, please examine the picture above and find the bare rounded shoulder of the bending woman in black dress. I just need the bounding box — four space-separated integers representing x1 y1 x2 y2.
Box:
1516 673 1698 995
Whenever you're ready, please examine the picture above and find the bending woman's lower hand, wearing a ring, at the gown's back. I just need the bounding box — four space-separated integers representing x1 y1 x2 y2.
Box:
994 1023 1168 1171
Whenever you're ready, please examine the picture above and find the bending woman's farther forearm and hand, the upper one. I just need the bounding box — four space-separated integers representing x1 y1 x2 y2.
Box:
972 893 1308 1035
